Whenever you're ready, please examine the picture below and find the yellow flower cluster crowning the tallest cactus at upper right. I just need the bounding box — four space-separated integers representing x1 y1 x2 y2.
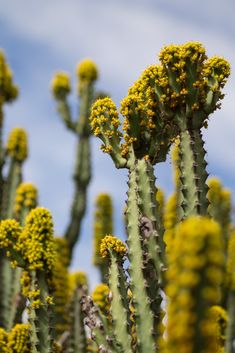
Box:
159 42 230 119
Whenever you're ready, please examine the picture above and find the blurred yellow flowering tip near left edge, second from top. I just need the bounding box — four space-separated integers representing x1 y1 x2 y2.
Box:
6 127 28 162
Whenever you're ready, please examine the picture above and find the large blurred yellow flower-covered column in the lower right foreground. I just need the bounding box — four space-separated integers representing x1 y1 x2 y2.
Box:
166 216 224 353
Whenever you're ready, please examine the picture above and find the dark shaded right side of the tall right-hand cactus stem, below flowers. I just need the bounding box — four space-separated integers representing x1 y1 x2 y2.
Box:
189 129 209 216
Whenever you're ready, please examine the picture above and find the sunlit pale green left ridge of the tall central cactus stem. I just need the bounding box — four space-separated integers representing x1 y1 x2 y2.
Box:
126 168 155 353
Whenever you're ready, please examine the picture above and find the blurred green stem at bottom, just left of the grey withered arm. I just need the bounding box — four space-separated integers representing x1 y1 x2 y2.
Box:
68 287 87 353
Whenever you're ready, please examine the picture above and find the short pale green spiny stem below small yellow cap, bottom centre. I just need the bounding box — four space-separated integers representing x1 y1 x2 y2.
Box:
109 254 132 353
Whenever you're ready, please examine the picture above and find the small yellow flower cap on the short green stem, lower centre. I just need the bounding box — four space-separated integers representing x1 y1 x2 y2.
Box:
100 235 127 258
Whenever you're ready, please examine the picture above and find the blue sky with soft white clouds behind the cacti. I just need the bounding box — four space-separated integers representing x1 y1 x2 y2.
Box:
0 0 235 287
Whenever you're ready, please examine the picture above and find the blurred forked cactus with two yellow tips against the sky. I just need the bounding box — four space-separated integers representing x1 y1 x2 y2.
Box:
52 59 98 257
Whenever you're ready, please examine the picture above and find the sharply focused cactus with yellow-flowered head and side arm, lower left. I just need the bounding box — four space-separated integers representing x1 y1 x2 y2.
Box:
0 207 55 353
